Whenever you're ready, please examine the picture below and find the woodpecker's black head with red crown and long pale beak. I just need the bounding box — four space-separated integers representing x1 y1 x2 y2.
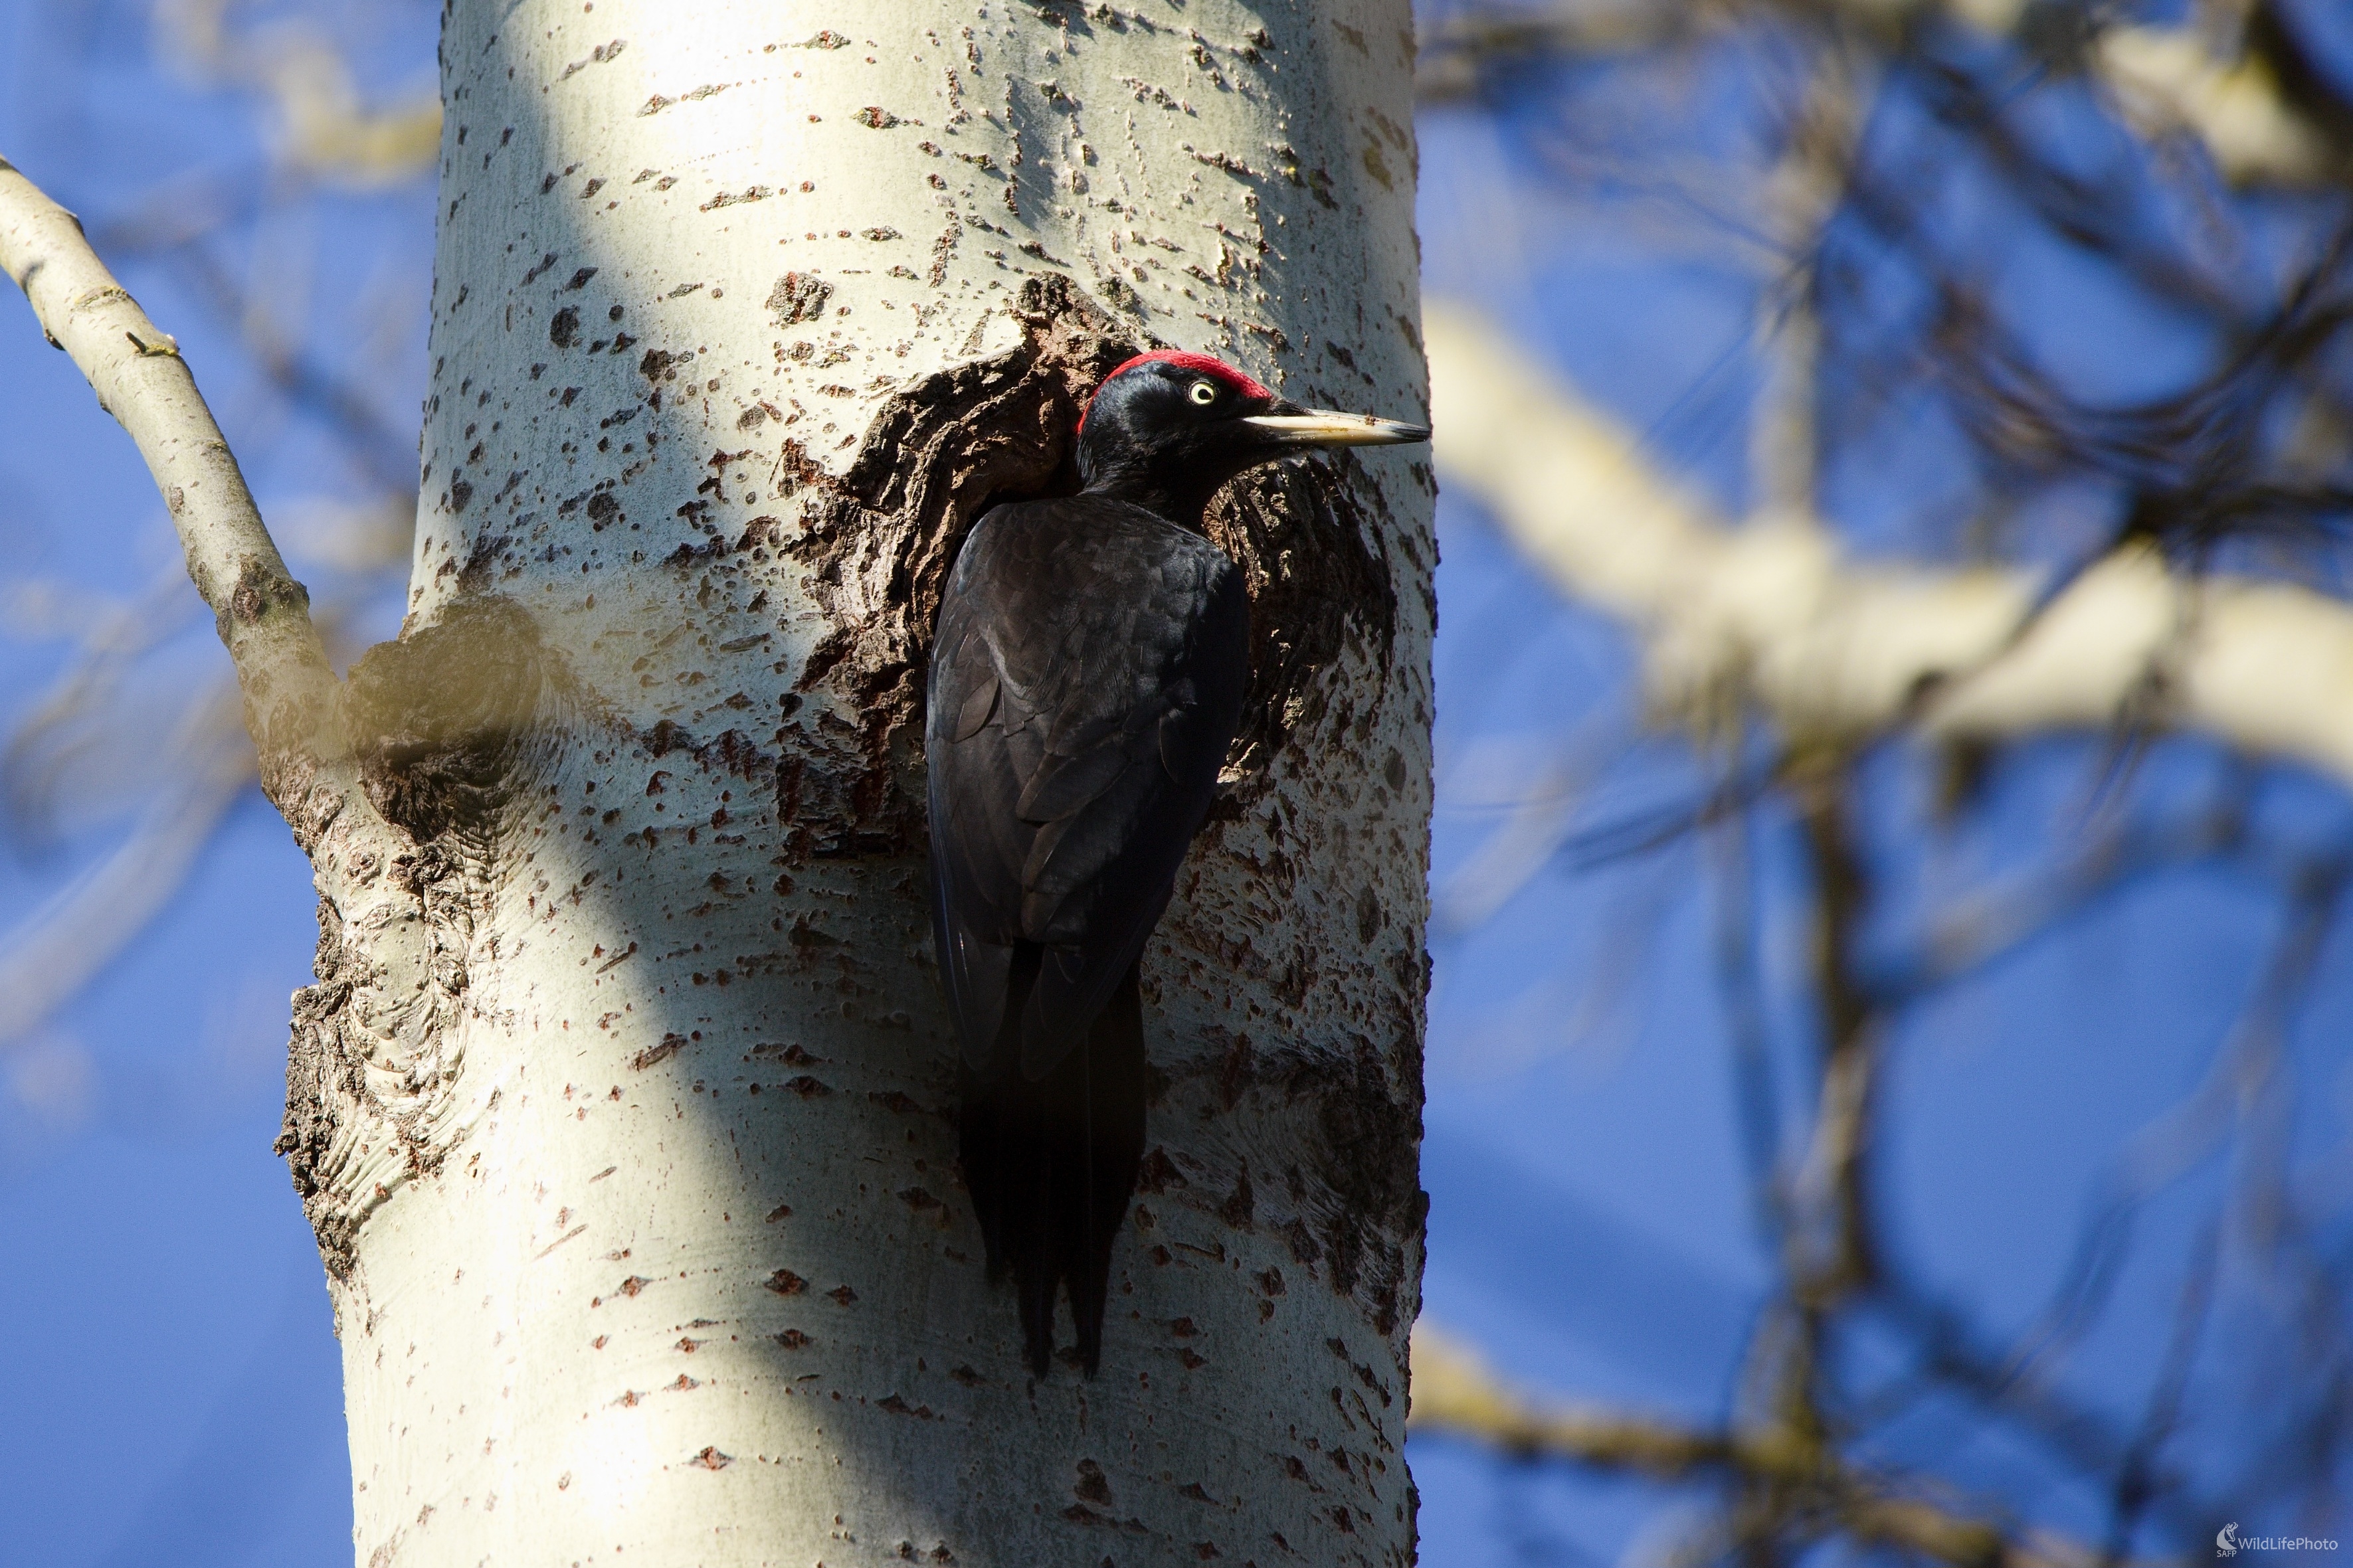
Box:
1078 348 1431 529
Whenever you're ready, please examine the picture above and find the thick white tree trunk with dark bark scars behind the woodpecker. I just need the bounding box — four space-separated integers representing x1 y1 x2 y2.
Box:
284 0 1436 1568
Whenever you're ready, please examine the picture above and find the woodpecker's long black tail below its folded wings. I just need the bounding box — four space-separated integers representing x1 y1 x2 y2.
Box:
958 942 1146 1377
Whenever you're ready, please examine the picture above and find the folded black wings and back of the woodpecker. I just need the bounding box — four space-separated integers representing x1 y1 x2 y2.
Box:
927 496 1250 1079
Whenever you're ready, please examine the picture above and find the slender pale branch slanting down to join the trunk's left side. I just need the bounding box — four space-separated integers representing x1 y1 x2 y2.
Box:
0 160 351 827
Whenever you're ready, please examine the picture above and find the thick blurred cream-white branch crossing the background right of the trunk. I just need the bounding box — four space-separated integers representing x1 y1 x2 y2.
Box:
1426 304 2353 783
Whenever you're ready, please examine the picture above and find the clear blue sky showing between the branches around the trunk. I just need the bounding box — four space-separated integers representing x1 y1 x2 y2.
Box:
0 0 2353 1568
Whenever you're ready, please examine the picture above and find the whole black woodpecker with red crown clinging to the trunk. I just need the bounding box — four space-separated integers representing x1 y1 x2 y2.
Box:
925 350 1431 1377
